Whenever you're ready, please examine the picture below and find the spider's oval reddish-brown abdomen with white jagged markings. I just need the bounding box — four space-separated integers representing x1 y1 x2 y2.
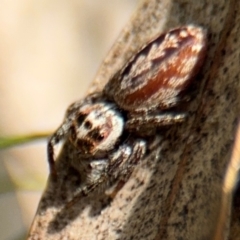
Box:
104 25 206 112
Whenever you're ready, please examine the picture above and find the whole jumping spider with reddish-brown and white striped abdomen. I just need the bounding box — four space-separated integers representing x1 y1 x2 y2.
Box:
48 25 206 200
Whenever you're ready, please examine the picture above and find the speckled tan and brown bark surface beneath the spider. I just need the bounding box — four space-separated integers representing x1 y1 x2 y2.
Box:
28 0 240 240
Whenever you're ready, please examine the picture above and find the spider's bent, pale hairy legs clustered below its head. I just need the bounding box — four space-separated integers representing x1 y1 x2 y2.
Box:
68 140 146 206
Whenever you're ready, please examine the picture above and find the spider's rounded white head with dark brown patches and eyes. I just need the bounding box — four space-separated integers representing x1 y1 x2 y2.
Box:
73 103 124 154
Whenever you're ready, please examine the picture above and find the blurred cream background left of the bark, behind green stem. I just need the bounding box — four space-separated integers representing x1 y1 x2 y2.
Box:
0 0 139 240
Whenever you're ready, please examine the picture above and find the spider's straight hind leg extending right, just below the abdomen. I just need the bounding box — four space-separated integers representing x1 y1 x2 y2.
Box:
125 112 187 134
